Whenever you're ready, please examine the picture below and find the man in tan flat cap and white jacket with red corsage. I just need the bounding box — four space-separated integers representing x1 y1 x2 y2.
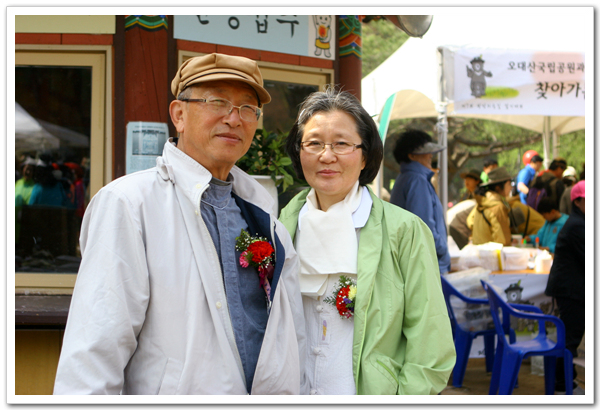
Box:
54 54 307 394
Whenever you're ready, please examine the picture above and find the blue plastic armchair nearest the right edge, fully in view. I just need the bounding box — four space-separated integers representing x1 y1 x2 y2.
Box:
481 280 573 395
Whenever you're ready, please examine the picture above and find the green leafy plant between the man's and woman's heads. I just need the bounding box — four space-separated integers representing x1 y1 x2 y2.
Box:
237 129 295 192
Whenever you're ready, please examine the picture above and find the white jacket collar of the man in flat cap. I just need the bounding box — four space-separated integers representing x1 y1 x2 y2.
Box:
156 138 275 213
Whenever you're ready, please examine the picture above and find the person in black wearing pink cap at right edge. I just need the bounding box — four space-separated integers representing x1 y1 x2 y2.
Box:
545 181 585 394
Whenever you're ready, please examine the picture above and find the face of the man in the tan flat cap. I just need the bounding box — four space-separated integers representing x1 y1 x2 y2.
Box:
170 81 258 180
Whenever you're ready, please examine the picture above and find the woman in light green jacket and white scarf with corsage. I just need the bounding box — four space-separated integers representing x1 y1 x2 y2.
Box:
279 89 456 394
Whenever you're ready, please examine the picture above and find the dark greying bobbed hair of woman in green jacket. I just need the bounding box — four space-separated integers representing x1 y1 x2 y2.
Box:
285 87 383 186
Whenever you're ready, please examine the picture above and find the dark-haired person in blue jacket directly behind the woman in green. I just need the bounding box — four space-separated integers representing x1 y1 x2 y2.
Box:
390 130 450 273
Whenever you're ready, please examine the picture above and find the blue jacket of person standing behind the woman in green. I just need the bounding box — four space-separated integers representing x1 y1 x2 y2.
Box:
390 161 450 273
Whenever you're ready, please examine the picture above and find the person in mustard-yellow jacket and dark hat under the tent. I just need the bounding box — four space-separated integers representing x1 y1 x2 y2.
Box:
467 167 512 246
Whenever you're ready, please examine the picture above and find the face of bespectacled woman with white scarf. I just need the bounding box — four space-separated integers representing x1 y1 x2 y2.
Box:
300 111 366 211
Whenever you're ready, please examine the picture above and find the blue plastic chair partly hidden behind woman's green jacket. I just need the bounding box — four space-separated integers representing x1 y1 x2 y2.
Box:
441 276 502 387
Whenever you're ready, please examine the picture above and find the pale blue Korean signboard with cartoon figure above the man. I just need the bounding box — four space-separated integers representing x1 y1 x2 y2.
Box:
173 15 336 60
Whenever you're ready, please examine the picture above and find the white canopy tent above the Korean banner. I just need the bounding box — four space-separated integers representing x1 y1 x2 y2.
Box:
361 8 593 207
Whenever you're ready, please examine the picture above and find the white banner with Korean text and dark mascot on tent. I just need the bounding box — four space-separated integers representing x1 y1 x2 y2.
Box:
442 47 585 116
